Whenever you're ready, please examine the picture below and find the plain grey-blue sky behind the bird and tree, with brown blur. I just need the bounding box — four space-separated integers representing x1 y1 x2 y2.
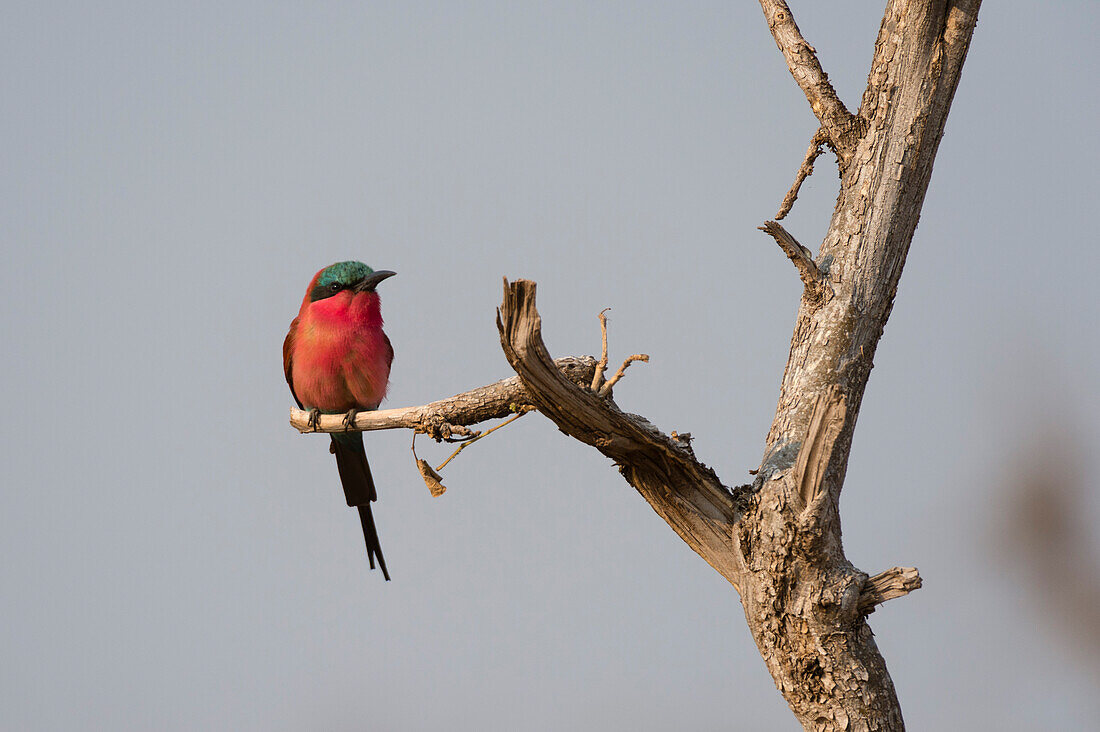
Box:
0 0 1100 730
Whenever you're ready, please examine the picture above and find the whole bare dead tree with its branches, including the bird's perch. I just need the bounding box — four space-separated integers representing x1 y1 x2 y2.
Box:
292 0 980 730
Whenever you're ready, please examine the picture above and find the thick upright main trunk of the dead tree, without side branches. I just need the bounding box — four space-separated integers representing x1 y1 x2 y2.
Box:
737 0 980 730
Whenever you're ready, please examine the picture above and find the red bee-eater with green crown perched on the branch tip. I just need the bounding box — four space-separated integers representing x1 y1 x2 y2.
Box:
283 262 396 580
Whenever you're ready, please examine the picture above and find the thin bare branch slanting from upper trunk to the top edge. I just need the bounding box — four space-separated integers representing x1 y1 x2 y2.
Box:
760 0 860 160
